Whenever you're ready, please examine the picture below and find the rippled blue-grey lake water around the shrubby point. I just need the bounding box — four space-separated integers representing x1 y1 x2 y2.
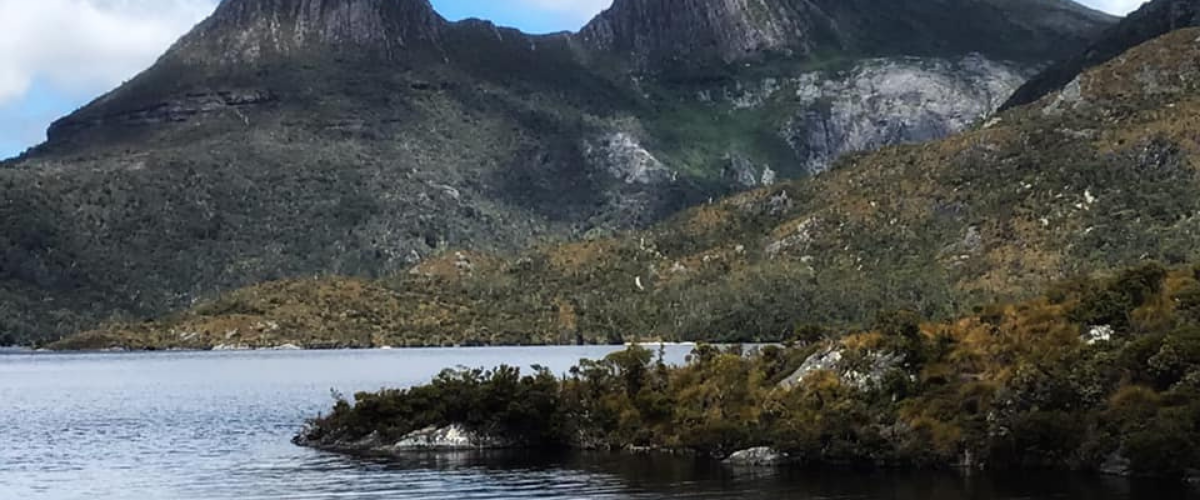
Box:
0 347 1200 500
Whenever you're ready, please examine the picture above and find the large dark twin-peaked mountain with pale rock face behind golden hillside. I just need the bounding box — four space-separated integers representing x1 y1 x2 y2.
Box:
0 0 1115 341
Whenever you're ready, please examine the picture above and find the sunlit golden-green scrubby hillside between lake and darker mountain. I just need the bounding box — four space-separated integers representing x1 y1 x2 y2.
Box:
61 29 1200 348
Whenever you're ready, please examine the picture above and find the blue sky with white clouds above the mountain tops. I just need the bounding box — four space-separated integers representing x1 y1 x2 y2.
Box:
0 0 1142 158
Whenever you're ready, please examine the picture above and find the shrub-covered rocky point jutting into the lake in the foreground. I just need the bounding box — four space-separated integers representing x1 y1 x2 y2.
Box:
295 265 1200 477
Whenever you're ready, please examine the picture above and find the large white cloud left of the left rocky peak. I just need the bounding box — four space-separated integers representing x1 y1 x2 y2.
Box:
0 0 216 104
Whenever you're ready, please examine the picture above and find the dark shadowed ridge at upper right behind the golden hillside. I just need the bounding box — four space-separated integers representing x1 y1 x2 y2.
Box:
1004 0 1200 108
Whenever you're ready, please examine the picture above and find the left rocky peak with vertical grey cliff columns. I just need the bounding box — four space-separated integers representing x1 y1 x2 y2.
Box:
173 0 446 62
